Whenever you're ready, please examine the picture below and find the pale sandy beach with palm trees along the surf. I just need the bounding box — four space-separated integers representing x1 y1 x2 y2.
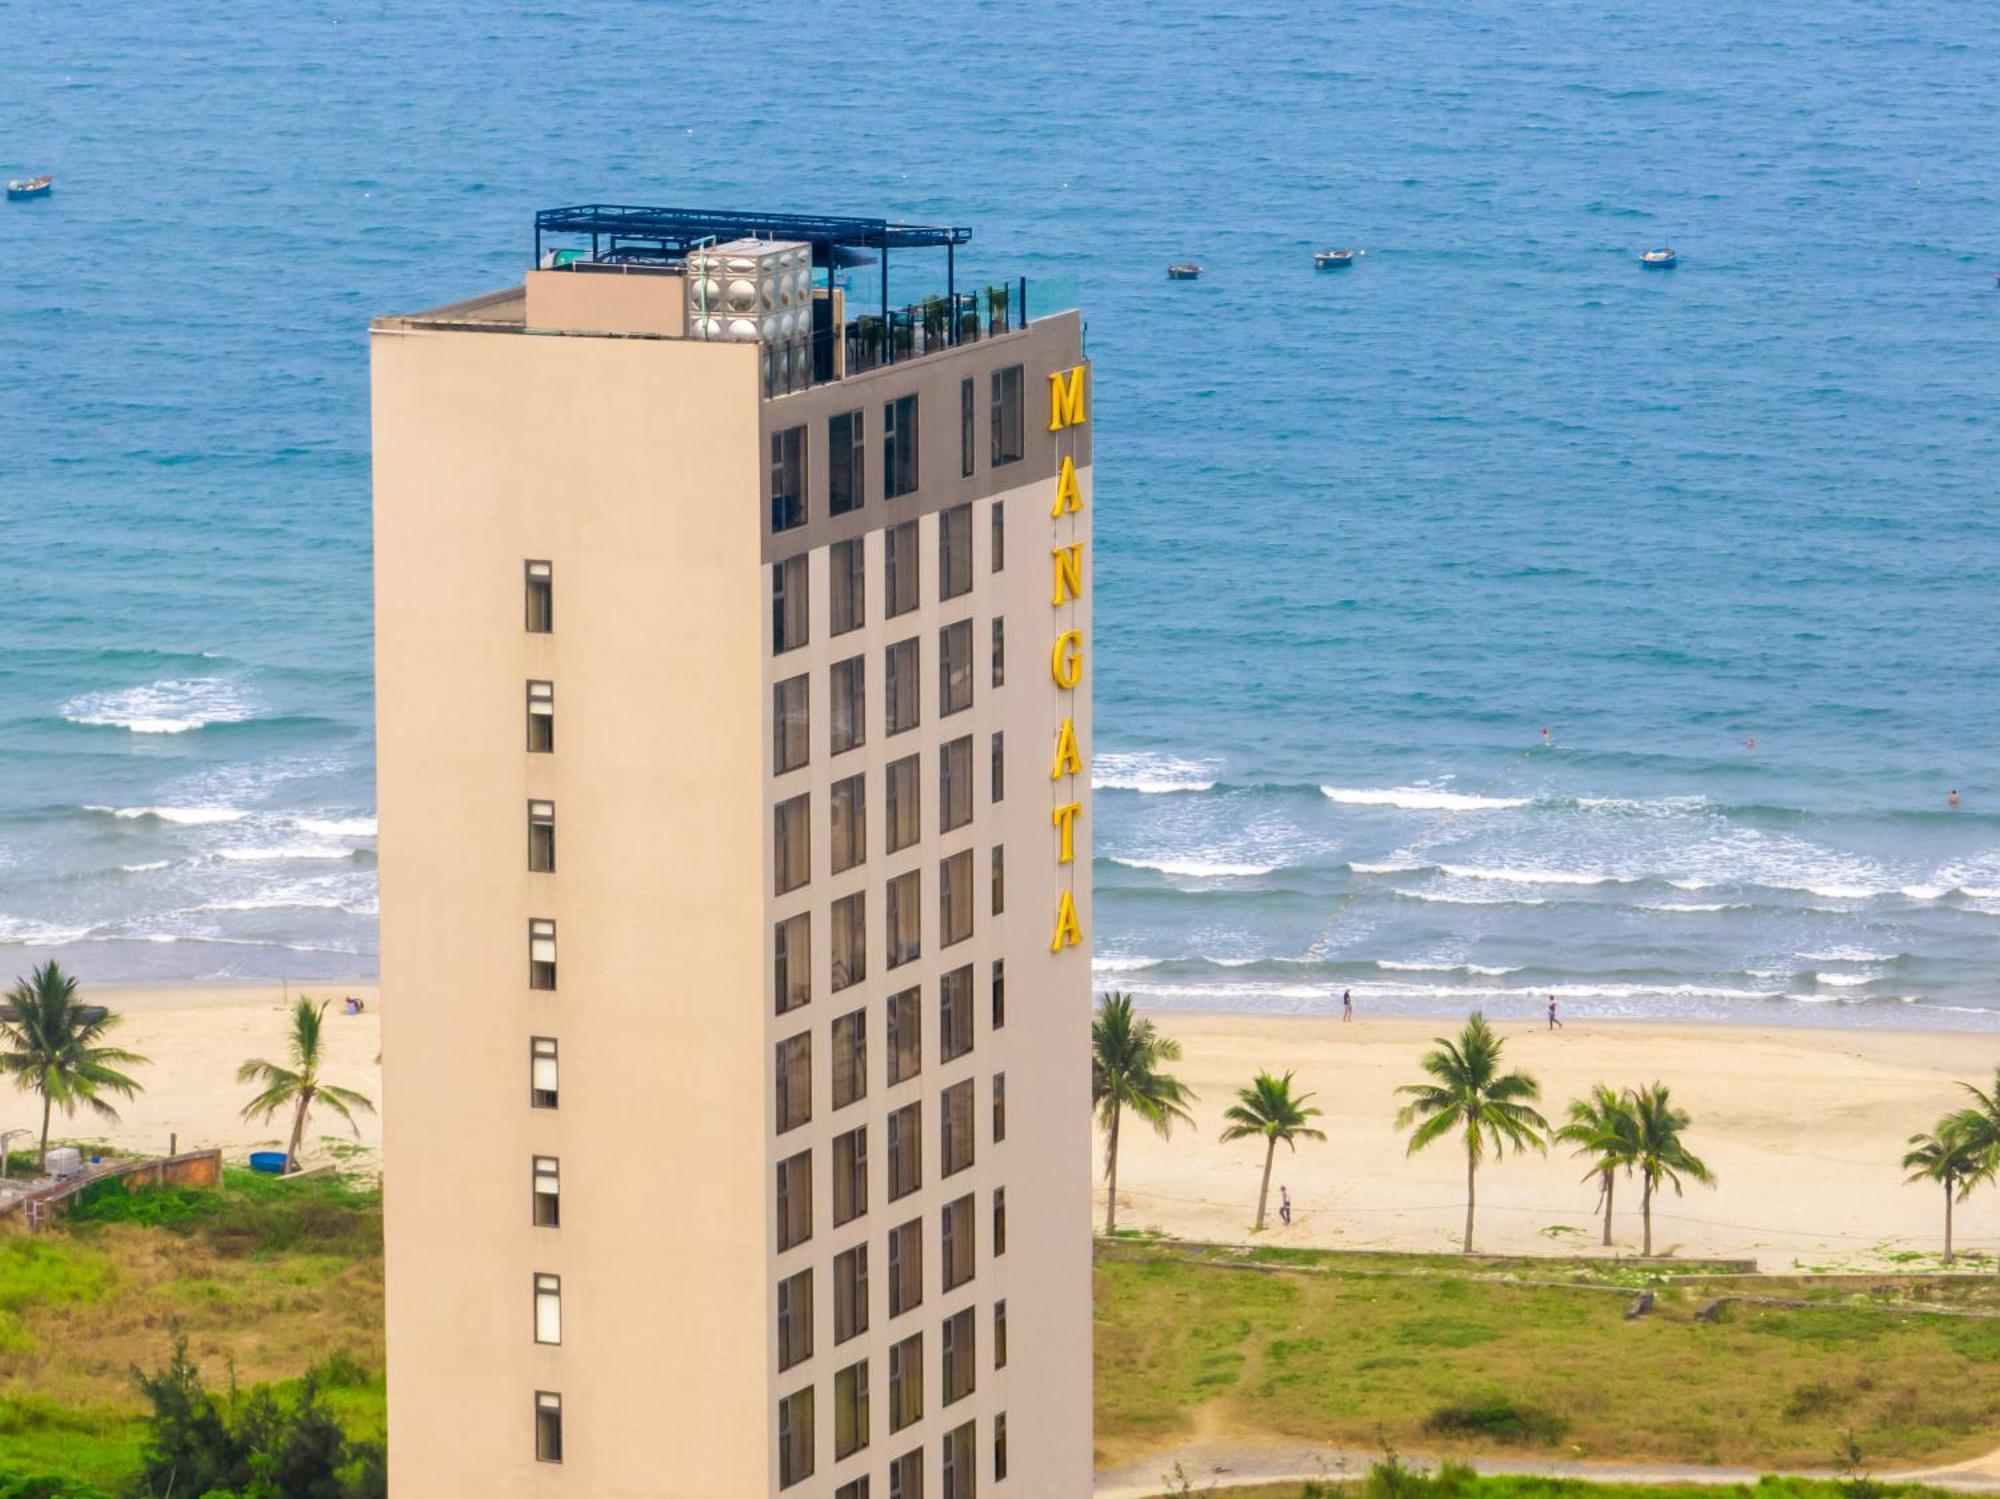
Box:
19 983 2000 1269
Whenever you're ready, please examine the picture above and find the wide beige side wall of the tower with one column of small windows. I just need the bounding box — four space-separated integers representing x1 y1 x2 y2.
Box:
374 323 770 1499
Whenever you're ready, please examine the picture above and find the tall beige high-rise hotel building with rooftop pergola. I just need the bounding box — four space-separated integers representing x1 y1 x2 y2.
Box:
372 206 1092 1499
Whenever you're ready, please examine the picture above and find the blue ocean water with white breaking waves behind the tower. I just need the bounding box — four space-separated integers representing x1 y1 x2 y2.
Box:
0 0 2000 1025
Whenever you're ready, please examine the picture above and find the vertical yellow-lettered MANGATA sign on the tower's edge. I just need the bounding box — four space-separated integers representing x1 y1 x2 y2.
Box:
1048 364 1090 953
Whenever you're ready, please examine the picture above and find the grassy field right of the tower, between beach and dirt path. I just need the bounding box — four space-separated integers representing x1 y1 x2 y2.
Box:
1096 1245 2000 1467
